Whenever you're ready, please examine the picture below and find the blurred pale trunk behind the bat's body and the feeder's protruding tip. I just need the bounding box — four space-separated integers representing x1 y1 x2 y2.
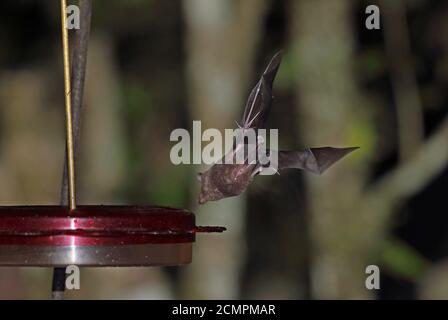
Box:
183 0 266 299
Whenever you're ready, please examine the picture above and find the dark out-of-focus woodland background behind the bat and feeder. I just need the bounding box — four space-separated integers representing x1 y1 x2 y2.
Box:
0 0 448 299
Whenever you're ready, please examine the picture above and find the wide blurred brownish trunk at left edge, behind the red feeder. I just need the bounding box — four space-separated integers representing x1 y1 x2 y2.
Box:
0 68 64 299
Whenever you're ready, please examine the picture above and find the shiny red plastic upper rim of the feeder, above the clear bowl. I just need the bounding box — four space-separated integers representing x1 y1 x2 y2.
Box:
0 206 225 246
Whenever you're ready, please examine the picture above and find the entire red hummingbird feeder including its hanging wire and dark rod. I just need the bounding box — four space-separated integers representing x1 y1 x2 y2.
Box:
0 0 225 267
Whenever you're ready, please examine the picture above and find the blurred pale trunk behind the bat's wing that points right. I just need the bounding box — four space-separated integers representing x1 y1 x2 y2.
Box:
293 0 371 298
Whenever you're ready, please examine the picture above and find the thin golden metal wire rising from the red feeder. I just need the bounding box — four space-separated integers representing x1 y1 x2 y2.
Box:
61 0 76 210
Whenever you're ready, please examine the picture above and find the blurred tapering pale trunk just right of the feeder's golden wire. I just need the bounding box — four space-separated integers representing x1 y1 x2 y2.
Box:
78 35 125 204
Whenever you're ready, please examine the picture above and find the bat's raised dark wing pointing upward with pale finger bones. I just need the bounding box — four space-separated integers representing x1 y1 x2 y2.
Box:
242 51 282 129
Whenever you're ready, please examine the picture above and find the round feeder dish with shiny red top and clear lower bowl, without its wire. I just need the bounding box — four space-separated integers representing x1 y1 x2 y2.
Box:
0 206 225 267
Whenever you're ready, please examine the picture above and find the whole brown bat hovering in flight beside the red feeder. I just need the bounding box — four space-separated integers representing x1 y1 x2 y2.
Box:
198 52 357 204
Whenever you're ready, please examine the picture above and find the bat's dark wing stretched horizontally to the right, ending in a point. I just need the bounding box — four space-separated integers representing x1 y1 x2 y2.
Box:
260 147 358 174
